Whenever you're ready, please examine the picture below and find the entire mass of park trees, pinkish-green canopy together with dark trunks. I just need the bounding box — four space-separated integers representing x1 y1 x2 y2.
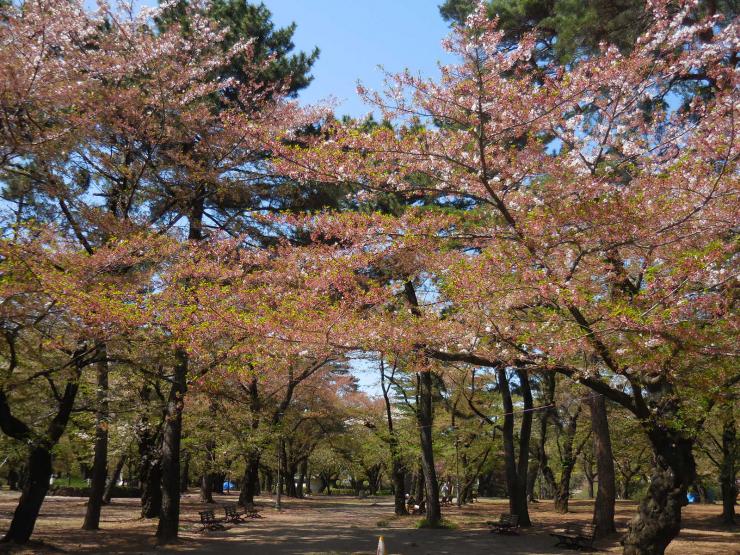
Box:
0 0 740 555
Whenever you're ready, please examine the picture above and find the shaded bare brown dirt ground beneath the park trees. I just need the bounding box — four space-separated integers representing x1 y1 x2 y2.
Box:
0 492 740 555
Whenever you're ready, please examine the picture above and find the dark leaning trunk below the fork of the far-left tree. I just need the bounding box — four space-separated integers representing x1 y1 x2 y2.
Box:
3 445 51 544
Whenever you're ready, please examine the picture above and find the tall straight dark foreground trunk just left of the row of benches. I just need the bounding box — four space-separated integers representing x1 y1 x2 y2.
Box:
157 349 188 545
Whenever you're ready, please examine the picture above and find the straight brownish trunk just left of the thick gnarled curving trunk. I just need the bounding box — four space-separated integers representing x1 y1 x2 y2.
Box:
588 392 617 537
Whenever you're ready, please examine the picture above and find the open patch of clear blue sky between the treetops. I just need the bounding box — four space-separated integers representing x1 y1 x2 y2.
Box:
263 0 451 116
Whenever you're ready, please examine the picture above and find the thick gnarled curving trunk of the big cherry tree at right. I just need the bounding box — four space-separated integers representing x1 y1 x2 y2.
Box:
624 378 696 555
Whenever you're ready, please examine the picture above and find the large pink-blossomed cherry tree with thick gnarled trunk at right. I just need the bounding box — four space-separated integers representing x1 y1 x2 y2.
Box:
274 2 738 554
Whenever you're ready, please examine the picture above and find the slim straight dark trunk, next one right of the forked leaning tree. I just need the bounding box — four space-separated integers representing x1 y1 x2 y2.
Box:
82 343 109 530
